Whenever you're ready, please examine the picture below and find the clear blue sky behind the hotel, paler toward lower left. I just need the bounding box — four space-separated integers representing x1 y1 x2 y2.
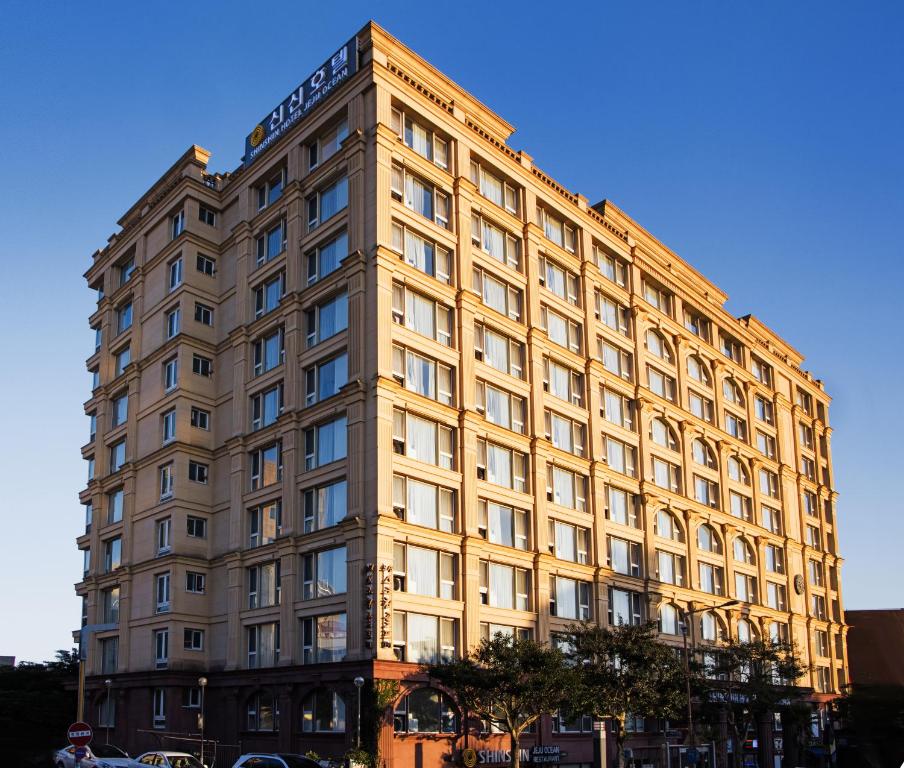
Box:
0 0 904 660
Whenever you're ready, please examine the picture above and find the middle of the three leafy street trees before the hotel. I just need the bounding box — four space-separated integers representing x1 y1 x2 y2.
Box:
568 622 687 768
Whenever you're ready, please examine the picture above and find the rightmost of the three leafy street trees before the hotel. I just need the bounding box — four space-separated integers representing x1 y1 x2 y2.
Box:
696 640 806 767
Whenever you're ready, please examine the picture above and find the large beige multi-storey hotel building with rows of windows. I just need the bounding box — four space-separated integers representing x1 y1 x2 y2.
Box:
77 19 847 765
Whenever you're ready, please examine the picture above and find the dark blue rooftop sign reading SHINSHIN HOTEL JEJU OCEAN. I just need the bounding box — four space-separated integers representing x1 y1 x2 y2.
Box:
244 37 358 168
